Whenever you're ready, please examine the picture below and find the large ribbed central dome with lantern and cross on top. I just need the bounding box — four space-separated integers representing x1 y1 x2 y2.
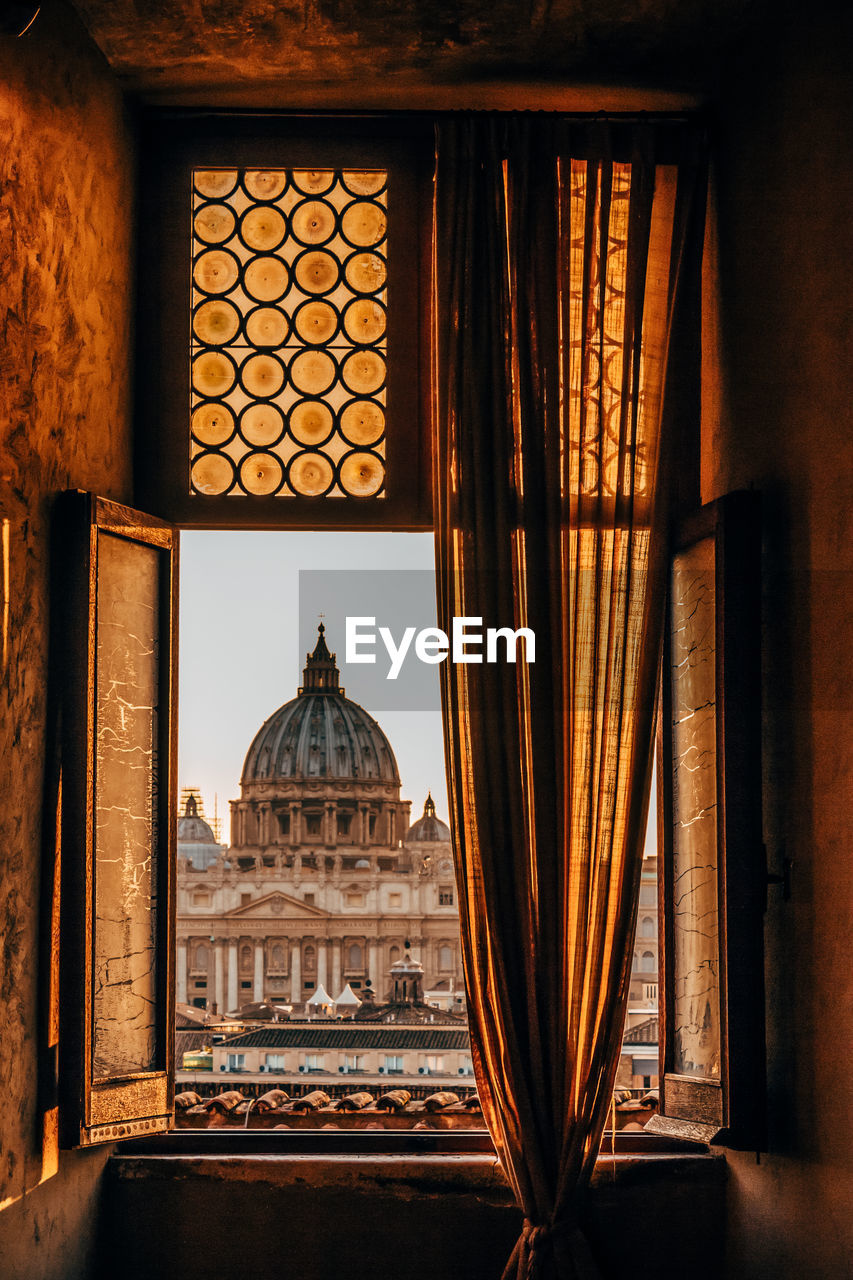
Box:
242 623 400 786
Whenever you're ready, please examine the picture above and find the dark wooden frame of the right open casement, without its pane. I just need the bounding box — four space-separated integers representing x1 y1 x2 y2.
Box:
648 492 767 1151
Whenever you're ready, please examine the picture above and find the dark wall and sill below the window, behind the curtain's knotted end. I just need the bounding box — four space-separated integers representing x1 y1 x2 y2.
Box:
104 1130 725 1280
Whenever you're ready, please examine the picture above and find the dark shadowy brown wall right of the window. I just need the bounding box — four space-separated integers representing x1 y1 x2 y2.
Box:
704 4 853 1280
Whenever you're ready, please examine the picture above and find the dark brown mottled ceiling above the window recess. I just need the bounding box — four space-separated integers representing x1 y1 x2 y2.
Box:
66 0 765 106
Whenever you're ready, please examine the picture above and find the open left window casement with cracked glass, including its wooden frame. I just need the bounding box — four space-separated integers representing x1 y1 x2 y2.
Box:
59 493 178 1147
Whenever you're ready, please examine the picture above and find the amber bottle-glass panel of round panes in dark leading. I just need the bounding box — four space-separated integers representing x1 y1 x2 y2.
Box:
190 169 388 498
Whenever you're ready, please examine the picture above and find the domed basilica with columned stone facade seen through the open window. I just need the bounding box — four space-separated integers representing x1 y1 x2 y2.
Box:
177 626 462 1016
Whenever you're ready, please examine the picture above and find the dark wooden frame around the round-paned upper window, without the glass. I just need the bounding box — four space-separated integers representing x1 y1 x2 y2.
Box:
134 111 433 531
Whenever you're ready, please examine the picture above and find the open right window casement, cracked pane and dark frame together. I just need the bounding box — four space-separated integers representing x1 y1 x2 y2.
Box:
648 493 767 1149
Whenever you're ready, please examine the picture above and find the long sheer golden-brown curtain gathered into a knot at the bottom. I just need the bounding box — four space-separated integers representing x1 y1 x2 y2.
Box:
433 115 704 1280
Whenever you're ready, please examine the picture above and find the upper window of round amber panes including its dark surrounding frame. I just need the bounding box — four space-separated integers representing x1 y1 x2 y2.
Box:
140 118 432 527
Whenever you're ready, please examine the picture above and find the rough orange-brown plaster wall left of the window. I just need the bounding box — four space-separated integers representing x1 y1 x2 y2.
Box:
0 0 133 1280
